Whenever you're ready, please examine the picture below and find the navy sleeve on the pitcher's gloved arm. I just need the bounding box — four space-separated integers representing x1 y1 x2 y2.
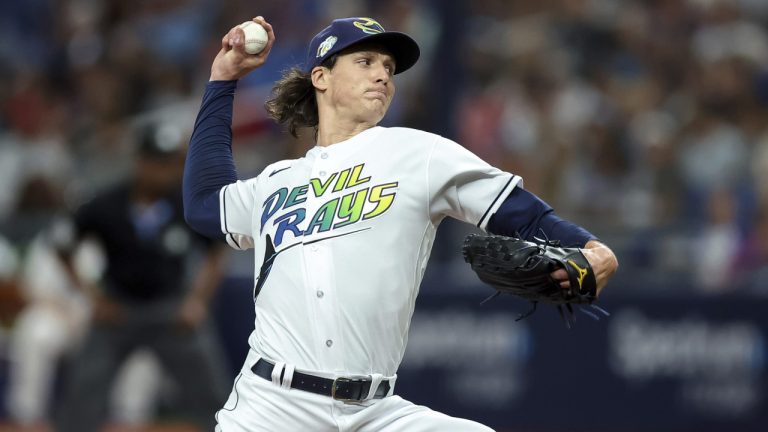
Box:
487 187 597 247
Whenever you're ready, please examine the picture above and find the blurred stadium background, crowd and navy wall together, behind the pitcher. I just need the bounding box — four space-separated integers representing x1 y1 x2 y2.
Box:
0 0 768 431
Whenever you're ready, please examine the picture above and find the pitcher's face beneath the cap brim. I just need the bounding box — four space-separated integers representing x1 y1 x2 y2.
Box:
327 46 395 124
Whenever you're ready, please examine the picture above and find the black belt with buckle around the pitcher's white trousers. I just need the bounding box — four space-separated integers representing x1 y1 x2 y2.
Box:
251 359 390 401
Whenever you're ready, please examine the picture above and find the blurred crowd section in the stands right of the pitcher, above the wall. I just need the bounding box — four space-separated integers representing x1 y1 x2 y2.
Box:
453 0 768 293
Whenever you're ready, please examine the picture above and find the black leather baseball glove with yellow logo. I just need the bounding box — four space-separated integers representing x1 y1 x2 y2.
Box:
462 234 608 327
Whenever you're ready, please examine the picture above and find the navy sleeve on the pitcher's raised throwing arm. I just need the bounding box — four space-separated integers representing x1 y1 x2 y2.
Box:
182 81 237 238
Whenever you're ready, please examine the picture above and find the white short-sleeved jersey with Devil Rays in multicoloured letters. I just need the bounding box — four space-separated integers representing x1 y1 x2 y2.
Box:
220 127 520 376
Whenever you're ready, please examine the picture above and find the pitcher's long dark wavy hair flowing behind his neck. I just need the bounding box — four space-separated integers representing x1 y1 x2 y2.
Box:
264 55 337 138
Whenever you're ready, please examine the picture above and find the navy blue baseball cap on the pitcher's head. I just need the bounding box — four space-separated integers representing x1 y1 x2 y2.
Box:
305 17 420 74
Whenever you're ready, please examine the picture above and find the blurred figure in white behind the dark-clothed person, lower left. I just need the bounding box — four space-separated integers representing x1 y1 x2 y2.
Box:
2 219 168 431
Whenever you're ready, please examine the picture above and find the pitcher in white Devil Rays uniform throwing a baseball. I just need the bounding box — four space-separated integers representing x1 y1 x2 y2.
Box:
184 17 617 432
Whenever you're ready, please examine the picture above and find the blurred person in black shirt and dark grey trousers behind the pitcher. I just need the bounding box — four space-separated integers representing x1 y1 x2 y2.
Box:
56 122 226 432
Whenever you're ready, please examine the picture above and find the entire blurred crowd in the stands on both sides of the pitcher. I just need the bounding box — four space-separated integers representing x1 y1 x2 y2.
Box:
0 0 768 426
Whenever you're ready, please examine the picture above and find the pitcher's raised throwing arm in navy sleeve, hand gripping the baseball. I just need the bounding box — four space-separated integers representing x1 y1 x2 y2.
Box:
182 17 275 238
